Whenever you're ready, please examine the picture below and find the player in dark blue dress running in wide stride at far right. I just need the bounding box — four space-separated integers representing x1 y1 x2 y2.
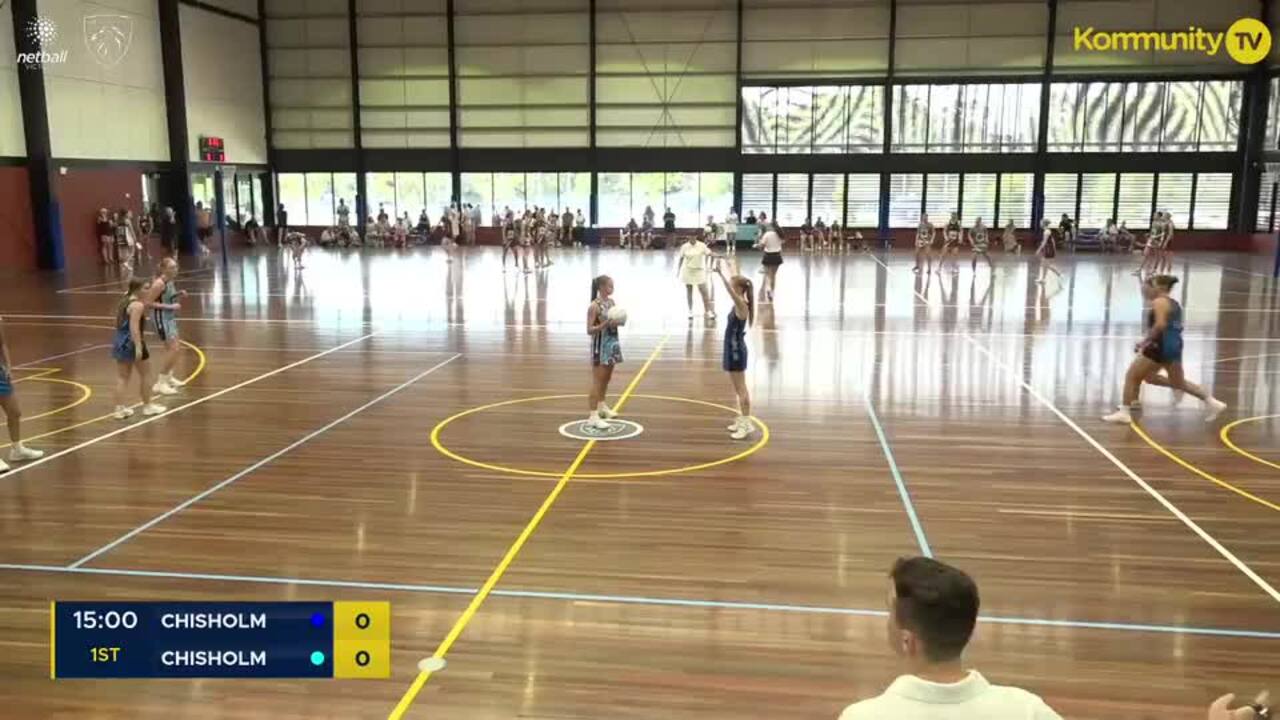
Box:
1102 275 1226 425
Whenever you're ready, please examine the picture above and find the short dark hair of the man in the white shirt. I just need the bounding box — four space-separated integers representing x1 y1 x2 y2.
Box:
890 557 979 662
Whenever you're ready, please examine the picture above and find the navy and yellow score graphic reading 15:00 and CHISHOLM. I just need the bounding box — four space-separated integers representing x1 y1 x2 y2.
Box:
49 602 392 680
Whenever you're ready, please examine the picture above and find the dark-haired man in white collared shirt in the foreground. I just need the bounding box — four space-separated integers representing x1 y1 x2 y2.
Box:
840 557 1062 720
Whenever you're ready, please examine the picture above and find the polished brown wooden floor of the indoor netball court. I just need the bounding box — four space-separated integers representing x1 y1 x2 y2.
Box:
0 243 1280 720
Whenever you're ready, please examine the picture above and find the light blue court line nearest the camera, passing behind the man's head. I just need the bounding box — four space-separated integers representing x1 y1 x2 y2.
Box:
0 562 1280 641
